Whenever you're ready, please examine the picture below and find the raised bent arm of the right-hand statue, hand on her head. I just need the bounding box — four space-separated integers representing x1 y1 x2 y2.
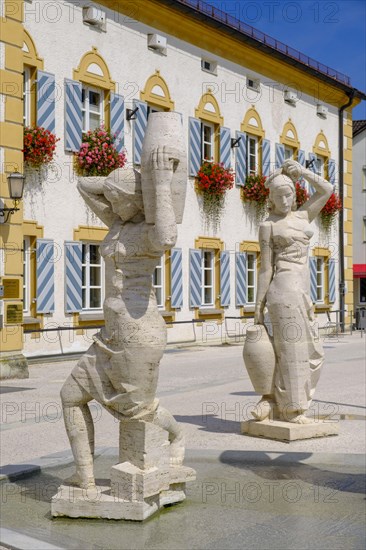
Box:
282 160 333 221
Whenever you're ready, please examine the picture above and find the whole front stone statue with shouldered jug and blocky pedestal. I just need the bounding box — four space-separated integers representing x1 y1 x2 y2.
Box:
52 112 195 520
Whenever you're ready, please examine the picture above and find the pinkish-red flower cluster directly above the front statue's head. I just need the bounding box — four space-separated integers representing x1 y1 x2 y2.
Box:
75 125 126 176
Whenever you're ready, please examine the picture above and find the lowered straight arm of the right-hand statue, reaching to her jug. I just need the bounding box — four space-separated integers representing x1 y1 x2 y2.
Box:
254 222 274 325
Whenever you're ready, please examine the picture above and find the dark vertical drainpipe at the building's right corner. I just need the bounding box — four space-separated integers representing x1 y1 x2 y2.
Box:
338 88 357 332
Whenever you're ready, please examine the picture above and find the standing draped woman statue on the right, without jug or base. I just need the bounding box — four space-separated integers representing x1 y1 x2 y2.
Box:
244 160 333 424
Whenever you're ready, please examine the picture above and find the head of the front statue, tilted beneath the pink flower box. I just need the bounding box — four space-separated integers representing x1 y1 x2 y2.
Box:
104 167 144 222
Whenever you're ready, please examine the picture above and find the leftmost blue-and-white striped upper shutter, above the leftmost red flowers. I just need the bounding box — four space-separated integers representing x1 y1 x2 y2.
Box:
37 71 56 133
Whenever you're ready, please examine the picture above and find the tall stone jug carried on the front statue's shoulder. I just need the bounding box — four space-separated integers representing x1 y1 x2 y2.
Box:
141 112 187 223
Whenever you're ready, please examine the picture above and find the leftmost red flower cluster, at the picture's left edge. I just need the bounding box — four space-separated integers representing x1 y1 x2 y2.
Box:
22 126 59 168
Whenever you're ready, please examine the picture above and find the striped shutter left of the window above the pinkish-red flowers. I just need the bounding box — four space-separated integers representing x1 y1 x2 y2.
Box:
65 78 83 153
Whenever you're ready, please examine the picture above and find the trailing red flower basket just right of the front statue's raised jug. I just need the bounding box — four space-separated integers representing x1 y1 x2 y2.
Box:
196 160 234 229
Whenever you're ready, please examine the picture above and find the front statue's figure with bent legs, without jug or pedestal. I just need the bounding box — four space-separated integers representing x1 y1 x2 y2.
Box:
61 147 184 488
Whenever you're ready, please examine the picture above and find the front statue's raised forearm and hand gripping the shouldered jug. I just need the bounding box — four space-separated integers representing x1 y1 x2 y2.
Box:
149 147 177 250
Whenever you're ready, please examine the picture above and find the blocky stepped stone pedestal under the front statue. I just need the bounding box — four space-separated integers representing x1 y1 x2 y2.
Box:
51 420 196 521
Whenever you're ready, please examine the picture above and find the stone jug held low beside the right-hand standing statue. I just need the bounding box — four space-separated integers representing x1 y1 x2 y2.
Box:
243 325 276 395
